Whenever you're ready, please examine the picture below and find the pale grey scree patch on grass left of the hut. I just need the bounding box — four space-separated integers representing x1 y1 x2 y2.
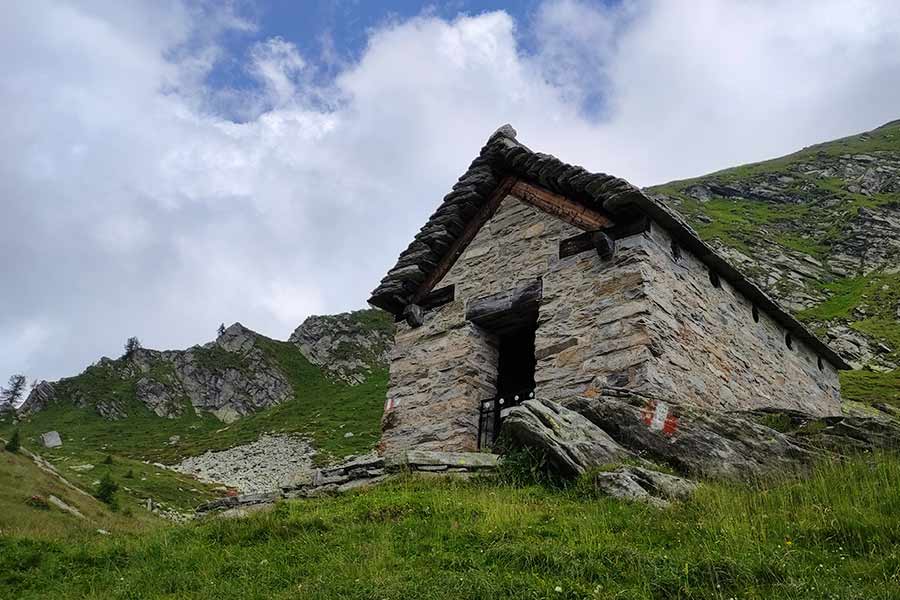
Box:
171 435 316 493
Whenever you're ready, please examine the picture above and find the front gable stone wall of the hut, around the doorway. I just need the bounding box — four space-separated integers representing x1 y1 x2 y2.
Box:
381 197 652 454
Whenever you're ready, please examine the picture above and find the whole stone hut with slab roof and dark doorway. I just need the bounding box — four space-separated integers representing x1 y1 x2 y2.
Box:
369 125 849 454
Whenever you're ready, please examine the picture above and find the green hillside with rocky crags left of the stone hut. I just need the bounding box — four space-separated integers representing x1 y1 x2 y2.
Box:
0 310 393 511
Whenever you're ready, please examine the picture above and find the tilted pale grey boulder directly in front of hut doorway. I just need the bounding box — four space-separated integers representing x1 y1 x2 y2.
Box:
503 400 635 477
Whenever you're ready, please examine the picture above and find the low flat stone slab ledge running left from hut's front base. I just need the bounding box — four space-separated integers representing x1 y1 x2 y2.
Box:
195 450 500 516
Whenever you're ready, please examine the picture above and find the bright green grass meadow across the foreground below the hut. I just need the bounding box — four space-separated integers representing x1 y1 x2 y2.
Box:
0 456 900 600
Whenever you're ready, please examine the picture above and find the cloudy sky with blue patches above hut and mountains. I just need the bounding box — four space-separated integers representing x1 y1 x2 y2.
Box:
0 0 900 383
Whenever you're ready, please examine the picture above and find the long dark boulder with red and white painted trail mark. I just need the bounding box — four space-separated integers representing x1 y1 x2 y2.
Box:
563 390 816 480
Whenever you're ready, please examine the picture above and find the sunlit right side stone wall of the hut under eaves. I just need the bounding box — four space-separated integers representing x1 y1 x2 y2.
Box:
641 226 841 415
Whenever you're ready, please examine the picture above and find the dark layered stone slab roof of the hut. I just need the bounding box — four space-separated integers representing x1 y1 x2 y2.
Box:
369 125 850 369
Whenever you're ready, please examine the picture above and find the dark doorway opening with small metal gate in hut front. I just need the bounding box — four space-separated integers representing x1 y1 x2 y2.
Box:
478 315 537 448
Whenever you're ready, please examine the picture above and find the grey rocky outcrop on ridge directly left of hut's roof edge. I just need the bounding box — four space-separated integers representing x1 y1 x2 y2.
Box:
288 309 394 385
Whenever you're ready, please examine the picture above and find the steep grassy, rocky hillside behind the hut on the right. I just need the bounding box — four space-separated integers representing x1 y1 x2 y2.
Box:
648 121 900 403
